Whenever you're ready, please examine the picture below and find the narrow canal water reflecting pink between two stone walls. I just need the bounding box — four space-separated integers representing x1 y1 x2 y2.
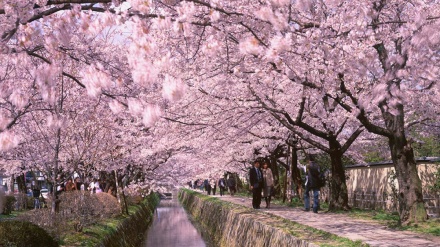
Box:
142 194 209 247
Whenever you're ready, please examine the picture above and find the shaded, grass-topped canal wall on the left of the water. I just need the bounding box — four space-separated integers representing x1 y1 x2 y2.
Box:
97 193 160 247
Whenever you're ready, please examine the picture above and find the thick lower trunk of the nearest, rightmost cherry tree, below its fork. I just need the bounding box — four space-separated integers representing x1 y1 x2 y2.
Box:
389 131 427 225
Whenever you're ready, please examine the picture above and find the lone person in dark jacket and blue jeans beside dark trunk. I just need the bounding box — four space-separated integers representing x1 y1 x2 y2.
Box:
304 156 320 213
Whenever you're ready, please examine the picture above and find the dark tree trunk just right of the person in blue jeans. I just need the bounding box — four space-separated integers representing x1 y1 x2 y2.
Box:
328 141 350 211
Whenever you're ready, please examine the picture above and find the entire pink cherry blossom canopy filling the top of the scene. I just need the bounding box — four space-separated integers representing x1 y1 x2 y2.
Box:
0 0 440 224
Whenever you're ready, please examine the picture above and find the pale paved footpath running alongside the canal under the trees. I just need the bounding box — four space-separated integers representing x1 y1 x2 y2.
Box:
211 195 440 247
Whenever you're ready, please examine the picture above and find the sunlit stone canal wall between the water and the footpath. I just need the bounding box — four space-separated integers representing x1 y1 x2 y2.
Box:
179 189 317 247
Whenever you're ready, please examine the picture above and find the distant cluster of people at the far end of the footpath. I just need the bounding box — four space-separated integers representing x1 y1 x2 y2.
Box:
188 175 237 196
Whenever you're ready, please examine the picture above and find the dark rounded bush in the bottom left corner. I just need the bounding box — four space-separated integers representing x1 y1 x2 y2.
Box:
0 221 58 247
